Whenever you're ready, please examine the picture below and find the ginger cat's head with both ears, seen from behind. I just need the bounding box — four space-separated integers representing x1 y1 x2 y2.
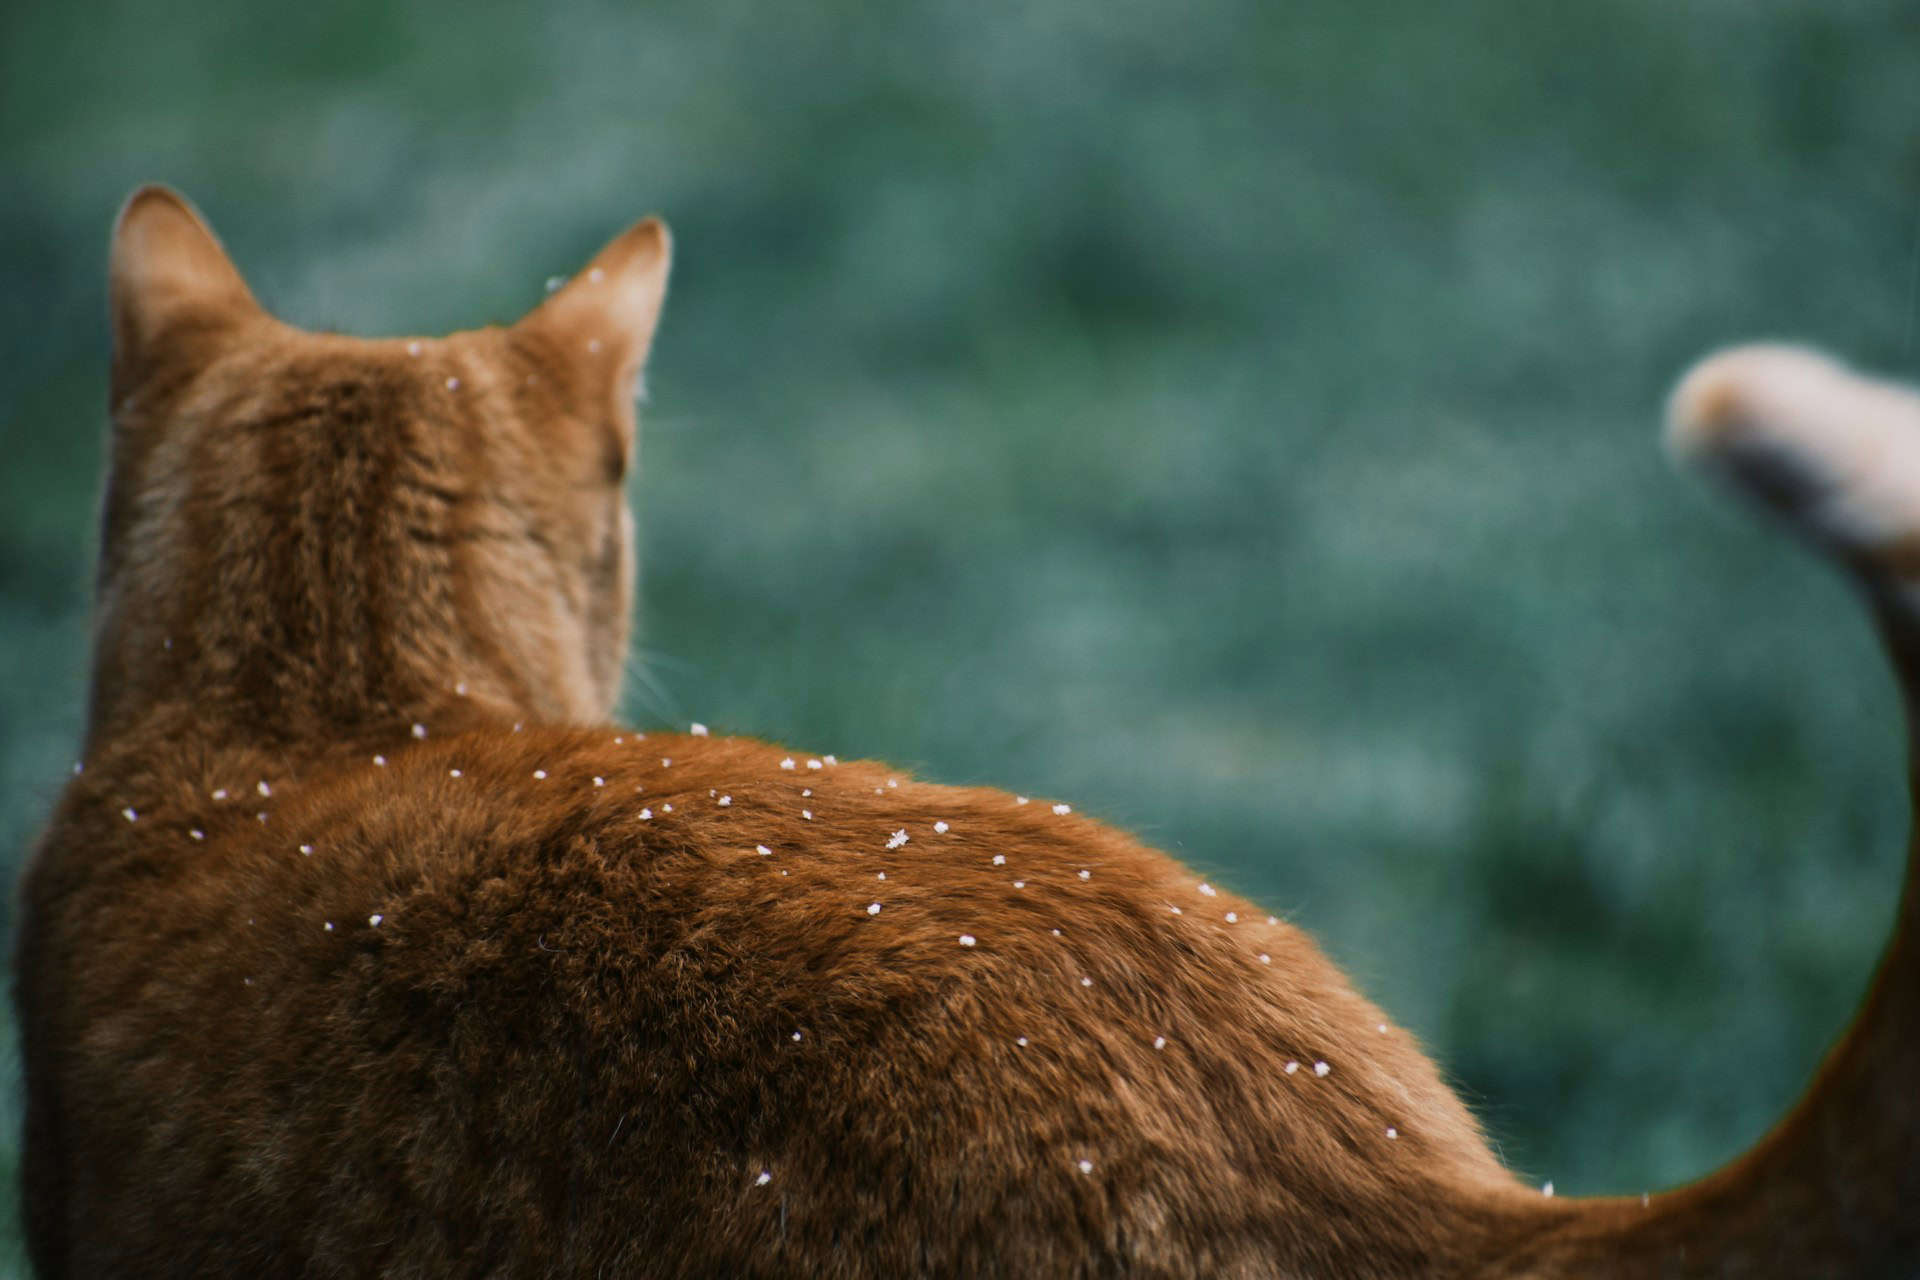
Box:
90 188 670 735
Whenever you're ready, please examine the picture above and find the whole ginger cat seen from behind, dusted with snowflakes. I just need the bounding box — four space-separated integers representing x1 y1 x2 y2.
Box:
15 188 1920 1278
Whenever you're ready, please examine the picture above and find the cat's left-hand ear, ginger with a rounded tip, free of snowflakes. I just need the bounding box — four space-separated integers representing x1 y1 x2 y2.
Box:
108 186 263 403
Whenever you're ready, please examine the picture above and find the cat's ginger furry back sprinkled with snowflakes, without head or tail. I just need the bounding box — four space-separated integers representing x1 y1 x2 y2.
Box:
18 725 1501 1274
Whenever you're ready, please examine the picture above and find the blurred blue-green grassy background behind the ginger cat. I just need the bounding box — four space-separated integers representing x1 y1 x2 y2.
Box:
0 0 1920 1258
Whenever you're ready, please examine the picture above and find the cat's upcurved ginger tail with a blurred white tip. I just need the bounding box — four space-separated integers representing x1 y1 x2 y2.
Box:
1511 345 1920 1276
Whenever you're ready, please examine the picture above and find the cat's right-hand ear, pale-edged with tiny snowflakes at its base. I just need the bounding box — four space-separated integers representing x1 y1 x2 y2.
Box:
515 217 674 397
